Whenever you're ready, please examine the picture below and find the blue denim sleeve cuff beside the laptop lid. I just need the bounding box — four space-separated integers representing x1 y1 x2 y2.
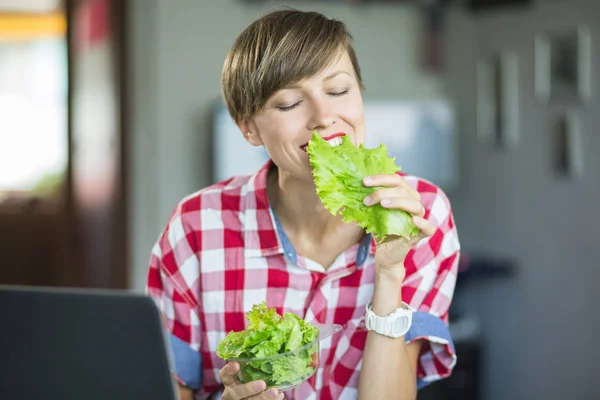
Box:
168 334 202 390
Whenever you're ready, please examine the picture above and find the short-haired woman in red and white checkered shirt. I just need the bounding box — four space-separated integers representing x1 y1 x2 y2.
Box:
148 10 459 400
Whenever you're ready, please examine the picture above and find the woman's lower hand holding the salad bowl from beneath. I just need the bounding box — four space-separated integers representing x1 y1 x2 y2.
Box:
219 363 284 400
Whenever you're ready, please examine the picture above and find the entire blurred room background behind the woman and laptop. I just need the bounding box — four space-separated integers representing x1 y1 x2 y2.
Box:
0 0 600 400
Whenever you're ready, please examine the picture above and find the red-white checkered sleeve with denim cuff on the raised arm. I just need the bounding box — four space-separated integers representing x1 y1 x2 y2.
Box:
402 177 460 387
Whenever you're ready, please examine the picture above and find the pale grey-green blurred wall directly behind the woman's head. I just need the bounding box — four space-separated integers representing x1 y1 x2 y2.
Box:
129 0 443 290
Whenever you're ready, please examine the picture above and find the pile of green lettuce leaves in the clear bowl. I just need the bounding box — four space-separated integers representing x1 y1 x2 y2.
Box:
217 302 319 387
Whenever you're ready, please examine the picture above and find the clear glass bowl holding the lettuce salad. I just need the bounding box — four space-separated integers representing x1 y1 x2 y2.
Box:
227 324 342 391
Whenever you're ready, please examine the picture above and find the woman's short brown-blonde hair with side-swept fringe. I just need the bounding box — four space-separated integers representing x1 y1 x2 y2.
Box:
221 10 364 122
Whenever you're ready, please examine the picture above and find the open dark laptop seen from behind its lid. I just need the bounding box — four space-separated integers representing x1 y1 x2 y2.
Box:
0 285 176 400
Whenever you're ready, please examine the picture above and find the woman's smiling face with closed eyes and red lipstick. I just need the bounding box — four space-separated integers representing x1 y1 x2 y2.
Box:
240 54 365 182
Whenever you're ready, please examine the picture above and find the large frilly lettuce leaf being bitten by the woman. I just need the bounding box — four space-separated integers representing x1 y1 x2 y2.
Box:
306 131 419 241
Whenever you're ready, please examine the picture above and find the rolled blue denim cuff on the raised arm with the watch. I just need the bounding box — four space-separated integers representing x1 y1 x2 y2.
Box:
404 312 456 389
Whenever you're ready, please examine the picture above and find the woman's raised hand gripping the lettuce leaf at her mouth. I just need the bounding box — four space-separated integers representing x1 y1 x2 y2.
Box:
363 174 435 279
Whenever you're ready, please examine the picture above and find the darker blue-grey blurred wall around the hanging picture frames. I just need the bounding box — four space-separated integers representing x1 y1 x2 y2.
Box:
448 0 600 400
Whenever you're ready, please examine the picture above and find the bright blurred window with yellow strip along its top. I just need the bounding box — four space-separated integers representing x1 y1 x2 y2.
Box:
0 13 68 203
